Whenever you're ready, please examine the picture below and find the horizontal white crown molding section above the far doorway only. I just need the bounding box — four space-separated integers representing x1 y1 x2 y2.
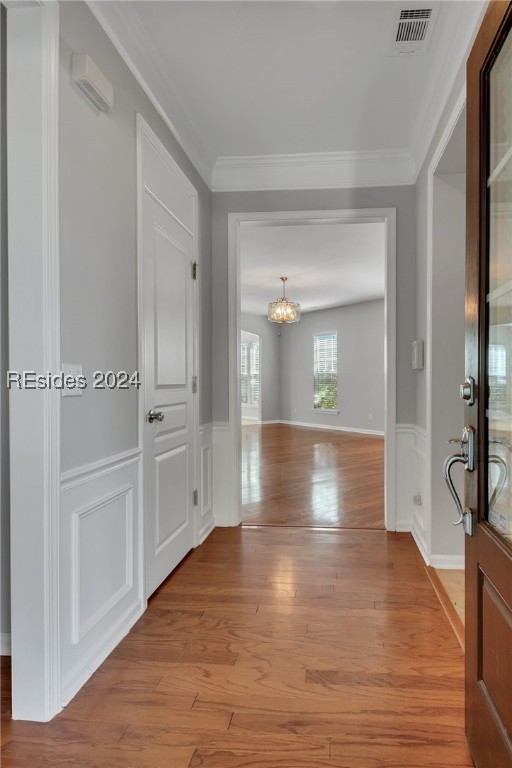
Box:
212 150 415 192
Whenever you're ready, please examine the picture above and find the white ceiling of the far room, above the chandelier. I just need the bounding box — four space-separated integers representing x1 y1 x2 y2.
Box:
240 222 386 315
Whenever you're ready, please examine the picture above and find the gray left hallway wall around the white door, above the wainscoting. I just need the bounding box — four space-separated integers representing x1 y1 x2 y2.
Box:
60 3 211 470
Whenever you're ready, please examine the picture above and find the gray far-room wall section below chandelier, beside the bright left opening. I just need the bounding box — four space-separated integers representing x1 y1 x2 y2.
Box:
241 314 281 421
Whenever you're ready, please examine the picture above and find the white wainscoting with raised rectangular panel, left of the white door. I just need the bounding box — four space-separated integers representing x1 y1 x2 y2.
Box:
59 449 146 706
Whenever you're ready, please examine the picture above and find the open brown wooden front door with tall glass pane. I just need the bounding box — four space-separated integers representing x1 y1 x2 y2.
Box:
465 2 512 768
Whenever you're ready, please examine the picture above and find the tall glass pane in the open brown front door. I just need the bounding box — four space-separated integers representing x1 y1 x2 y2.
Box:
487 28 512 540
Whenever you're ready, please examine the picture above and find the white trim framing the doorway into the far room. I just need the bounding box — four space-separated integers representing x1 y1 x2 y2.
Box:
223 208 396 531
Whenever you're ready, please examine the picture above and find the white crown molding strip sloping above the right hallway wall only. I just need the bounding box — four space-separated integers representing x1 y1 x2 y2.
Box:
411 0 488 182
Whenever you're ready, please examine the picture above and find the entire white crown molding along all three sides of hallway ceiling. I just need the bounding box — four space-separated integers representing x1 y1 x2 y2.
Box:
86 0 488 192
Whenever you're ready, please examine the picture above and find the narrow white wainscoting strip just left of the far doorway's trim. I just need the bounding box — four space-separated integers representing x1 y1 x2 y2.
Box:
212 422 234 526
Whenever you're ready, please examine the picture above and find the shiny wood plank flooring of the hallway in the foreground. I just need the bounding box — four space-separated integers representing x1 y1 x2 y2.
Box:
1 527 472 768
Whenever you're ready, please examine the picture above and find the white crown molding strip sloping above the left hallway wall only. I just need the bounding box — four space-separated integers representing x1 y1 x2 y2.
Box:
86 0 215 189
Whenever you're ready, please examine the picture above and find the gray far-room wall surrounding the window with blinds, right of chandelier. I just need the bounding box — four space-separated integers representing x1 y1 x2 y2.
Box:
281 301 384 432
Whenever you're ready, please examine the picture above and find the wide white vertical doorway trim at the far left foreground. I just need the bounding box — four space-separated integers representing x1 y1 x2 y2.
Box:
7 2 61 721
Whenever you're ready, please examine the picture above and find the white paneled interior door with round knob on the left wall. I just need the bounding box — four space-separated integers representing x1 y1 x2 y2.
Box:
142 120 195 596
